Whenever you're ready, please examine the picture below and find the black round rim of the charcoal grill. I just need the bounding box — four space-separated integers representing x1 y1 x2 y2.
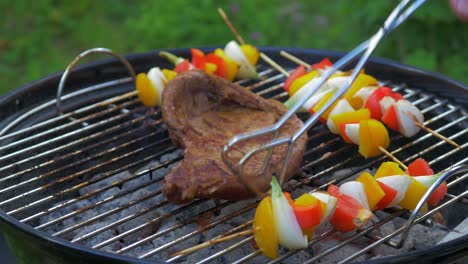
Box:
0 47 468 263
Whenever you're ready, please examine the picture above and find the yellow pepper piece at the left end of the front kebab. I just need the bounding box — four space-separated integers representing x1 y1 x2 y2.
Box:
253 196 278 259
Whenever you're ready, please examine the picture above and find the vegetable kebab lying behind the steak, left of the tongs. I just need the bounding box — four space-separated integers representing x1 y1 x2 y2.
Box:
136 40 259 107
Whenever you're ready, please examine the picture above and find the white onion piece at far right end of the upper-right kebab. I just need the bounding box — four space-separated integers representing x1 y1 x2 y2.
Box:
395 99 424 137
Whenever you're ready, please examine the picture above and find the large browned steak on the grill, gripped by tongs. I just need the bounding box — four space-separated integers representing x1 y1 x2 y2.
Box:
161 71 307 202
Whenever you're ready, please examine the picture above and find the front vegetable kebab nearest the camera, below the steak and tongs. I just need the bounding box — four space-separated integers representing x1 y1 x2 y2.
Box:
252 159 447 259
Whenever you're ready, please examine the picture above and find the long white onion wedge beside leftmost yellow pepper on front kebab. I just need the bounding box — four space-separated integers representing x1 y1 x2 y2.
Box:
271 176 307 249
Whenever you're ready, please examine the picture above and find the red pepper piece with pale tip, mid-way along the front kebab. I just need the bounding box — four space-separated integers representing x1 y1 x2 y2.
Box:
328 185 373 233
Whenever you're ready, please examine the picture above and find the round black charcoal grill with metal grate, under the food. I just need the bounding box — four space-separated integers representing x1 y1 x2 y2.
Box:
0 48 468 263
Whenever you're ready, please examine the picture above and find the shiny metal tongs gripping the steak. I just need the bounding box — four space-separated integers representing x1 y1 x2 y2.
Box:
222 0 426 194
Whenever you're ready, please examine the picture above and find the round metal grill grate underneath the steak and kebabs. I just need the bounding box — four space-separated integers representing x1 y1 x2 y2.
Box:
0 63 468 263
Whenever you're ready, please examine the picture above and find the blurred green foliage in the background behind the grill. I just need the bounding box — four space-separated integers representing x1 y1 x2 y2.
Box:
0 0 468 94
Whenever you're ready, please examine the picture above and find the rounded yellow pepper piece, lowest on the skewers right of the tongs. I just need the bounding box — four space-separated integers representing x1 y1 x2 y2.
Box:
359 119 390 158
